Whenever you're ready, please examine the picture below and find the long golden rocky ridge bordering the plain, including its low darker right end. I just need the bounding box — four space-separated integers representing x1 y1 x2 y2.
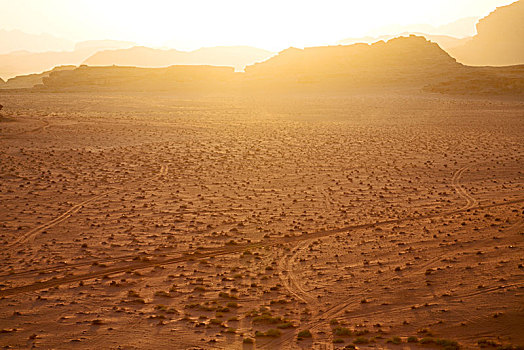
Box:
12 36 524 95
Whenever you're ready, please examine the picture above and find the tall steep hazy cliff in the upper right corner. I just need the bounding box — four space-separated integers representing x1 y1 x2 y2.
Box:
449 0 524 66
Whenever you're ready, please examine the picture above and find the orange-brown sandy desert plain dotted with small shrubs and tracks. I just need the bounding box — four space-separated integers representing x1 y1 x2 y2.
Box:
0 93 524 349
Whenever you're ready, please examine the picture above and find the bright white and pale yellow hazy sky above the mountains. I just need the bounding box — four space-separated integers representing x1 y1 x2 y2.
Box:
0 0 515 50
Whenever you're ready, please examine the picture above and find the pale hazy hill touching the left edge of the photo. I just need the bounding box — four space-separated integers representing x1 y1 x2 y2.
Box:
0 40 137 79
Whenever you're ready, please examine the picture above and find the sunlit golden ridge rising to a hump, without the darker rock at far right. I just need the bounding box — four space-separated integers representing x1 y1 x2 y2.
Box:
30 36 462 91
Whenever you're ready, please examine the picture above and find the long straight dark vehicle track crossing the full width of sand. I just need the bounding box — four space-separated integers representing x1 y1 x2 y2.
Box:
0 198 524 298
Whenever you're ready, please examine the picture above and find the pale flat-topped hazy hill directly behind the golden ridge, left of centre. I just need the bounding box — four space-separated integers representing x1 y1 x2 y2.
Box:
84 46 273 70
